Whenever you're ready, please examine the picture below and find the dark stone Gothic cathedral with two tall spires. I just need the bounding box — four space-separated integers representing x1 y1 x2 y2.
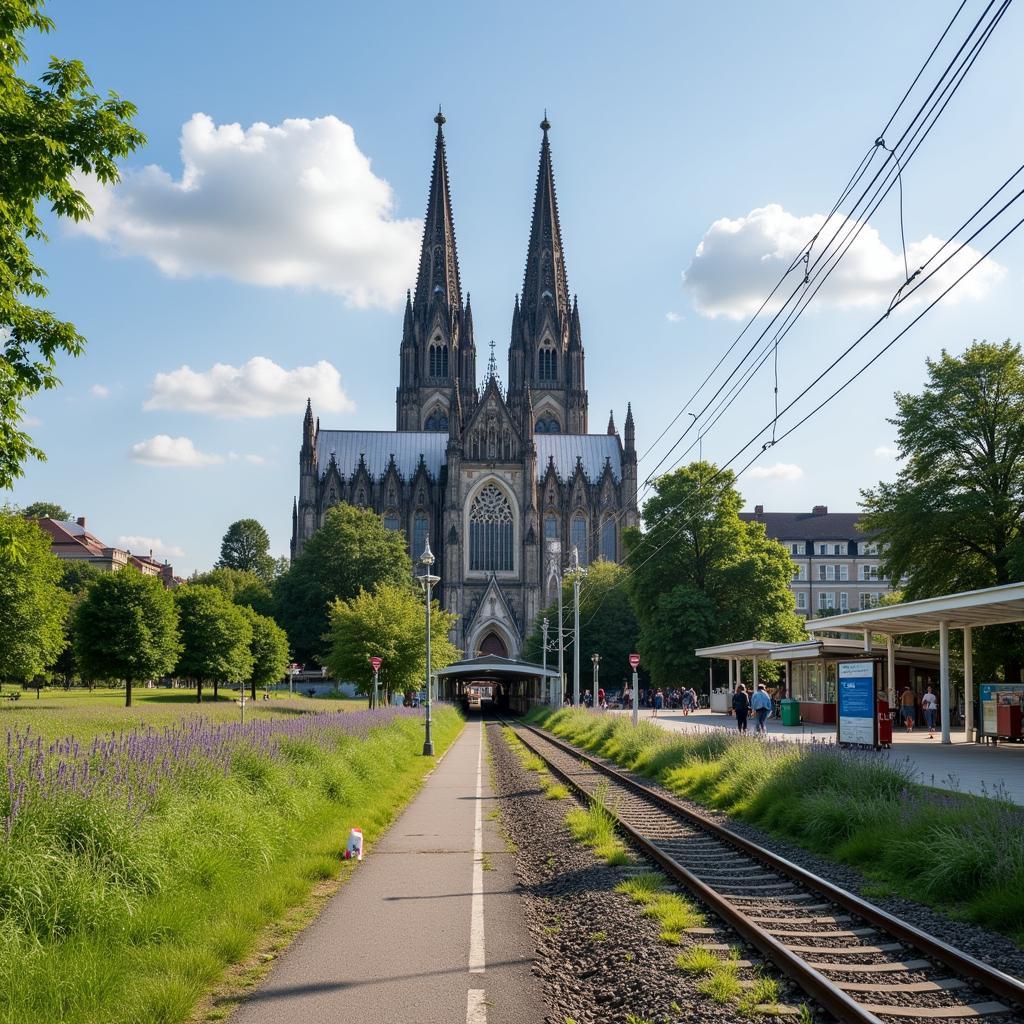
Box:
292 113 637 657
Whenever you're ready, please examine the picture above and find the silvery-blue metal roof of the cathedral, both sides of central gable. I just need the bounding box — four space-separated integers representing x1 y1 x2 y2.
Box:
316 430 623 483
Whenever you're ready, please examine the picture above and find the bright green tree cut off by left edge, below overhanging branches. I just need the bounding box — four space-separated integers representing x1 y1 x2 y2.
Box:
0 510 71 682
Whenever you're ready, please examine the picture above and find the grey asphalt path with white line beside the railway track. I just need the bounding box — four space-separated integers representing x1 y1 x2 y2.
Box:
231 721 548 1024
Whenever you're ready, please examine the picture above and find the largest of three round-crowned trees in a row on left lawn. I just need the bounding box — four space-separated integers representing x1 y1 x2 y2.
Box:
74 566 180 708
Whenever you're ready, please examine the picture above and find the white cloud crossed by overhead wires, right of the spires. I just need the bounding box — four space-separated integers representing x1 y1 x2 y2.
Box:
683 203 1006 319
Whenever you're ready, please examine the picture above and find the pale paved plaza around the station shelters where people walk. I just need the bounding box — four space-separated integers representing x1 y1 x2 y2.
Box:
611 709 1024 804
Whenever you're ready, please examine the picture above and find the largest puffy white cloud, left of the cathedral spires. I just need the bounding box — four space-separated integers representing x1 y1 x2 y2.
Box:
77 114 423 307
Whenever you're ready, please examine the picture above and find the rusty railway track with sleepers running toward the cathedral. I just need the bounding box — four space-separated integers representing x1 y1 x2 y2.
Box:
505 722 1024 1024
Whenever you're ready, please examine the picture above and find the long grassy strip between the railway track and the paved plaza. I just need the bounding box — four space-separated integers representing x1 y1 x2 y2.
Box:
528 710 1024 944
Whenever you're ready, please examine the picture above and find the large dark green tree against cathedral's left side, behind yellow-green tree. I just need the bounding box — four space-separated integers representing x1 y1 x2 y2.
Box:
274 504 416 663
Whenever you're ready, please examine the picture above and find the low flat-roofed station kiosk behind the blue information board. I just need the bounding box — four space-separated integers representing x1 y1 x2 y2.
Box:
694 637 939 725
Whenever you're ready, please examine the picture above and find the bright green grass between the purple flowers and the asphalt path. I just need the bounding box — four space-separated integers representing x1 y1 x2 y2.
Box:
0 695 462 1024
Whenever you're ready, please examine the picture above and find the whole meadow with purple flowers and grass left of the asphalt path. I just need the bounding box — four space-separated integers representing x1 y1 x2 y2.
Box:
0 691 462 1024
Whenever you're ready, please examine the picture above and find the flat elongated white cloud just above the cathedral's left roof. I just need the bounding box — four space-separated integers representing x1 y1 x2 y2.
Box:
142 355 355 419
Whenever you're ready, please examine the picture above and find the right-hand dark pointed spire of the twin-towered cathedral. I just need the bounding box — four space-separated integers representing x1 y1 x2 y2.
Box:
522 112 569 330
